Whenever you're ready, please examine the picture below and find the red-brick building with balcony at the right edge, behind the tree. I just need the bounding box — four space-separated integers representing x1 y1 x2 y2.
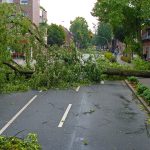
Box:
142 27 150 60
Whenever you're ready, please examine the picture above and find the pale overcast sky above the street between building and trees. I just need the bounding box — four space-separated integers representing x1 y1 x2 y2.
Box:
40 0 97 30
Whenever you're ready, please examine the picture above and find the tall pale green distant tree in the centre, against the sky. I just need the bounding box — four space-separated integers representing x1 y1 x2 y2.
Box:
70 17 90 48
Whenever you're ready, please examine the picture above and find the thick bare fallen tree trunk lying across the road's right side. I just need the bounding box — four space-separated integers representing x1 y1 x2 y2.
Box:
103 68 150 78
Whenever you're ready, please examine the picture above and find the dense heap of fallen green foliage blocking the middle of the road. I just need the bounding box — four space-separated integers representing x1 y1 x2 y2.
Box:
30 48 101 89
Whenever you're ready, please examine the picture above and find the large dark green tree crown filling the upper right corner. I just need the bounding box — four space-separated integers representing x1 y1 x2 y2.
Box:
92 0 150 52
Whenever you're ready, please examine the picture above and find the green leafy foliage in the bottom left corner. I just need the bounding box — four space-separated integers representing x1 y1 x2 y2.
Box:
0 133 41 150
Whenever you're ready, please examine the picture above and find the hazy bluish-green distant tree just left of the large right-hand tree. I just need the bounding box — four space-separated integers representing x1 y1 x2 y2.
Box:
95 22 112 47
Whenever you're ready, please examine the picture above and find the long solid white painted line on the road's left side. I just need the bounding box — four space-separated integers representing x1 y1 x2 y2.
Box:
0 95 37 135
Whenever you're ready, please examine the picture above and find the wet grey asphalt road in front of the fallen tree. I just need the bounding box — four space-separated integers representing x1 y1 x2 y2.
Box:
0 82 150 150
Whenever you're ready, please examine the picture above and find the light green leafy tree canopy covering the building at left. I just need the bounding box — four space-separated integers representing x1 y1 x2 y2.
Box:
0 3 44 63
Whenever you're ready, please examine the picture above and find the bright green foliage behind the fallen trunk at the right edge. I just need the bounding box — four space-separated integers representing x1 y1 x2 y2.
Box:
132 57 150 71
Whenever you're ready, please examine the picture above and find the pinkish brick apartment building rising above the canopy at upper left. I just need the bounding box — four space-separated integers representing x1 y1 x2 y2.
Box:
0 0 40 26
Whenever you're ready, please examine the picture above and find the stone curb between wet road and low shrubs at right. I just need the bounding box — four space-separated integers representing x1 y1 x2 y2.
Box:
125 80 150 114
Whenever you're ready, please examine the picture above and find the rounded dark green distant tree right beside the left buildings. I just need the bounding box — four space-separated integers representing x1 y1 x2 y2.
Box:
47 24 66 46
